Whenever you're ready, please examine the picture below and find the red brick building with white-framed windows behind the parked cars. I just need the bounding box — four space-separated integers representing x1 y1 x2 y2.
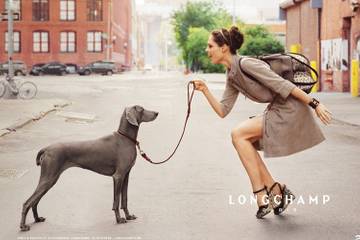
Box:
0 0 132 69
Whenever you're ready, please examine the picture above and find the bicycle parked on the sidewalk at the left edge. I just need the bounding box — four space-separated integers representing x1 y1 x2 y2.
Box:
0 76 37 99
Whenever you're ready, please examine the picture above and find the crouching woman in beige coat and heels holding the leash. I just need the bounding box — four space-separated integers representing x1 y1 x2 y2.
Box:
194 27 331 218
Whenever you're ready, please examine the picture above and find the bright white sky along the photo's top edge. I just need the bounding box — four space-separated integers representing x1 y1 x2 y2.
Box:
135 0 284 22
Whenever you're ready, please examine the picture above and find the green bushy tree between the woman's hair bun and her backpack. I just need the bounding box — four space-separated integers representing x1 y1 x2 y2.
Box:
239 25 285 56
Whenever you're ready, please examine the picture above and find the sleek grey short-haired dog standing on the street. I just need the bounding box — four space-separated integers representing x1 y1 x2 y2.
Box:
20 106 158 231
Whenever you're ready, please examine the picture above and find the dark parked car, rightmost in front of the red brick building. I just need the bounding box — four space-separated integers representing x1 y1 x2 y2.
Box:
78 61 119 75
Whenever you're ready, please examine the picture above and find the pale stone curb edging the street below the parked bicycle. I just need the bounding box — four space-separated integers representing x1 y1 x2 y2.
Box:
0 102 71 137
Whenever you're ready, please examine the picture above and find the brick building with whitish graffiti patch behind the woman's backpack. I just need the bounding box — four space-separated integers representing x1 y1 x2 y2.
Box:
280 0 360 92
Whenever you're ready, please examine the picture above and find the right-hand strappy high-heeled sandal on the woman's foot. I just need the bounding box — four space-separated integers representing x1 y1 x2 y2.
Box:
269 182 296 215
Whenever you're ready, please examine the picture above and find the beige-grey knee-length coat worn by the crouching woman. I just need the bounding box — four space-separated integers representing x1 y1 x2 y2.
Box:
220 55 325 157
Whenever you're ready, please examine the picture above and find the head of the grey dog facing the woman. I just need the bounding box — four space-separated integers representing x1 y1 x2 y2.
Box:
125 105 159 127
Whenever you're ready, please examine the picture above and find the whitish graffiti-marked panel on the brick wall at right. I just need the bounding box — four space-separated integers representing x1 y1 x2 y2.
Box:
321 38 349 71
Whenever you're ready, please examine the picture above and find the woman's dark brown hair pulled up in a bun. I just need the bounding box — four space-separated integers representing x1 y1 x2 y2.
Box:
211 26 244 54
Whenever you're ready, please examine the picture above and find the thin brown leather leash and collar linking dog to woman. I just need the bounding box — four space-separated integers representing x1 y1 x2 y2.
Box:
118 81 195 164
